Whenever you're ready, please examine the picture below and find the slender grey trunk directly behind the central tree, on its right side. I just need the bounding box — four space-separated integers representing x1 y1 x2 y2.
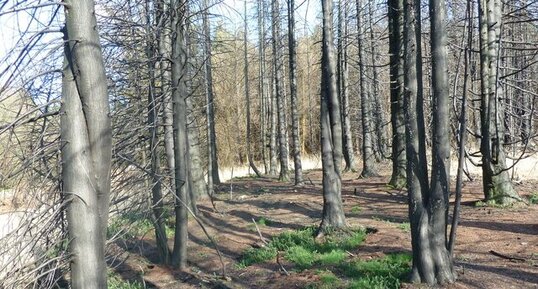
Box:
337 0 356 171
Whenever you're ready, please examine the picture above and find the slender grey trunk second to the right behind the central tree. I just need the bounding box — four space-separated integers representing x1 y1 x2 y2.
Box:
356 0 377 178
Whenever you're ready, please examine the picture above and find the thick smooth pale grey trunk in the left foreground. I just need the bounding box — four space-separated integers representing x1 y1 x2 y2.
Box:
61 0 112 289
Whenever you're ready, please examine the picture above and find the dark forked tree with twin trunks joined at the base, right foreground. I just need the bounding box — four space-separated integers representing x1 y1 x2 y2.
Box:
404 0 455 285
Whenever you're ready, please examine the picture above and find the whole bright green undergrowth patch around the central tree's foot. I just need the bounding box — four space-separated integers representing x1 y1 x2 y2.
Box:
238 227 411 289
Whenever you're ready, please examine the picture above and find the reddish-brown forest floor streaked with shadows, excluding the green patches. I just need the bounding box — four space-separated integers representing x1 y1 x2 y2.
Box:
115 170 538 289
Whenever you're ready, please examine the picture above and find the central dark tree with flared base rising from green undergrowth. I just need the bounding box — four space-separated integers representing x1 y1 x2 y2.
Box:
320 0 346 233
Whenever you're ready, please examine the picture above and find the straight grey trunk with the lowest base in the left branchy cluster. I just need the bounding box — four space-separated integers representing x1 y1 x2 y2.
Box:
171 0 189 269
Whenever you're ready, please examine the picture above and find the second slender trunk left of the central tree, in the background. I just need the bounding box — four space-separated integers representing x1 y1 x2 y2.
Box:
271 0 289 182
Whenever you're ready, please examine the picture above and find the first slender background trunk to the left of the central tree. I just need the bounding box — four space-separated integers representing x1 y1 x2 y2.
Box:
288 0 303 185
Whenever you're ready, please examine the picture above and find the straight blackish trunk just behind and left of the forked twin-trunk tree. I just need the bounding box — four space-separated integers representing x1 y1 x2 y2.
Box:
388 0 407 188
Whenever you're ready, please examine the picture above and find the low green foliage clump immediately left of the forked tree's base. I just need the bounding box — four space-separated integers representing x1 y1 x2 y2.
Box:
341 253 411 289
